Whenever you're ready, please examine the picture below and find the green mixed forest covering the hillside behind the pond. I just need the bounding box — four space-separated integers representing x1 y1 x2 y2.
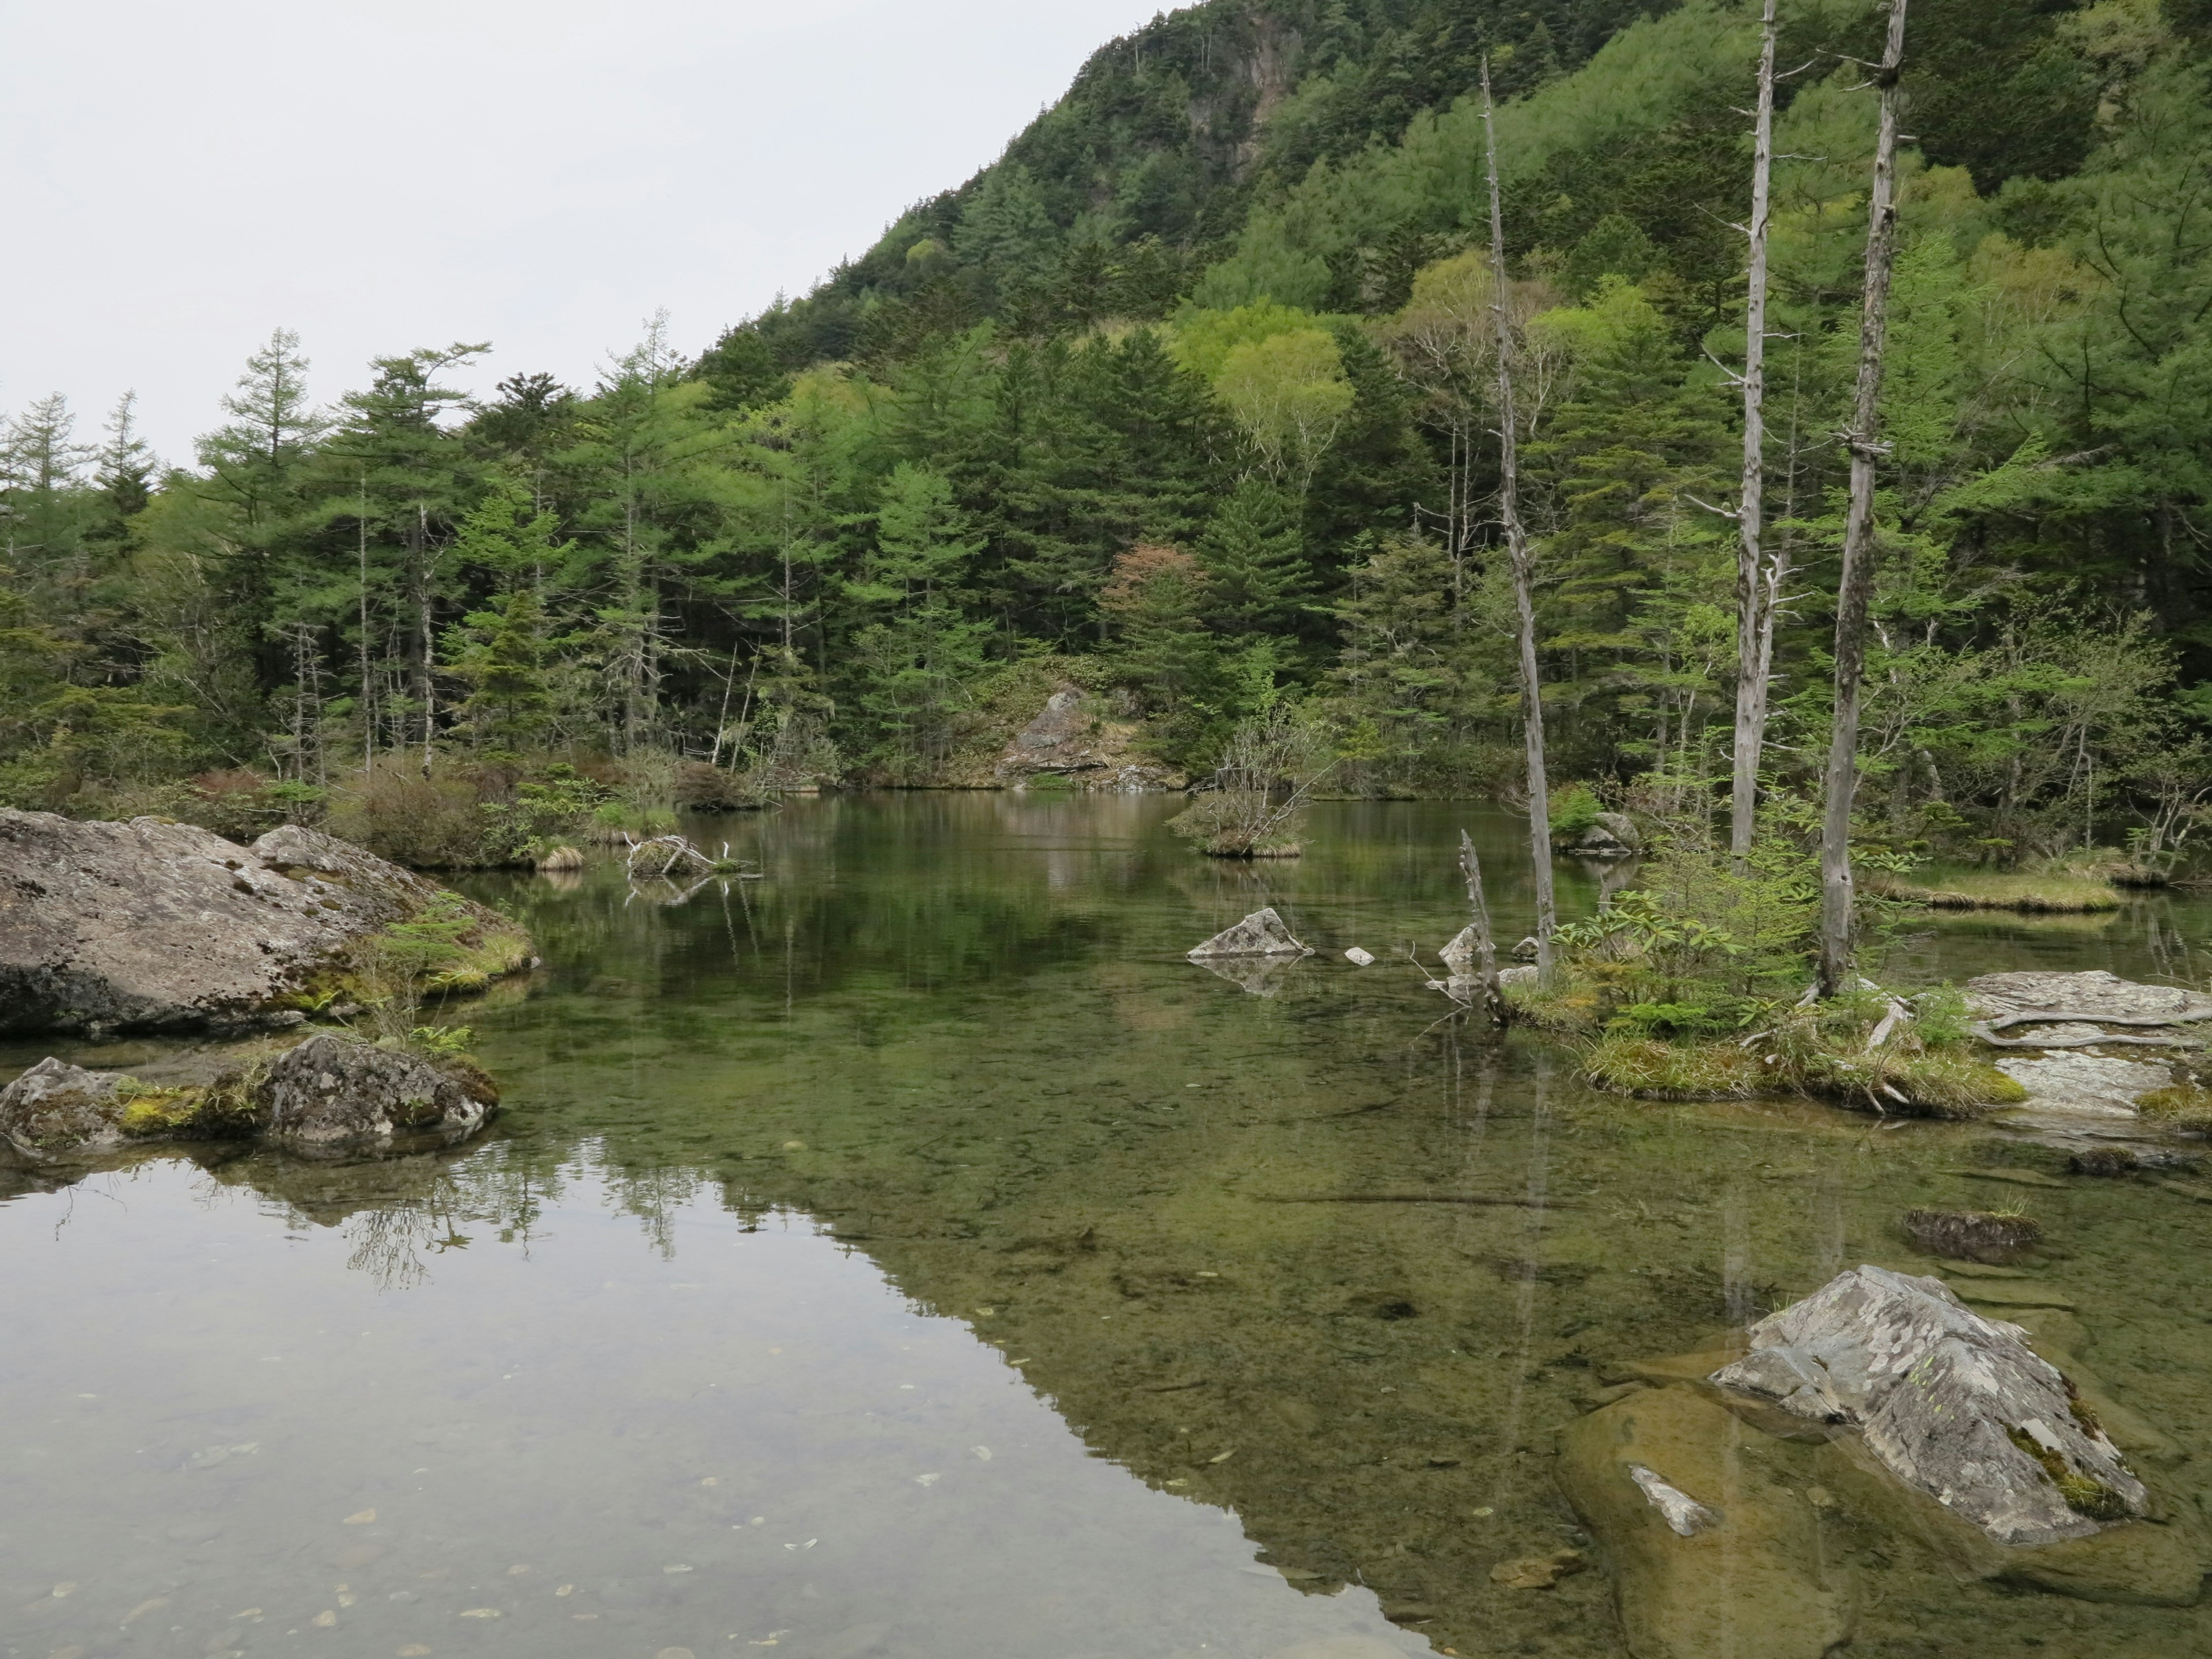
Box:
0 0 2212 885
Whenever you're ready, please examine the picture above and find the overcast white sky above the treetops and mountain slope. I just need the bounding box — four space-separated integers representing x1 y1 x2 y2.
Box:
0 0 1159 460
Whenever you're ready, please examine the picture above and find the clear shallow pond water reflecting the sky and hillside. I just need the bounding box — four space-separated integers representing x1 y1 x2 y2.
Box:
0 794 2212 1659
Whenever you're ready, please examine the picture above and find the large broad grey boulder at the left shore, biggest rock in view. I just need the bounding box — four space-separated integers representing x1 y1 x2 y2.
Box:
0 812 531 1033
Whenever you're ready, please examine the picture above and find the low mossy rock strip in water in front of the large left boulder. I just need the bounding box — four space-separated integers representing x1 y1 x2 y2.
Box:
0 1031 500 1164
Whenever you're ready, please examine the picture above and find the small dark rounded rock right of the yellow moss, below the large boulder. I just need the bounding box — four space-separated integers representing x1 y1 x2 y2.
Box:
252 1033 500 1150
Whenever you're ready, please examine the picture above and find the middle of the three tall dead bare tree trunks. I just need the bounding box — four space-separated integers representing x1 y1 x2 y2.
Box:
1728 0 1781 867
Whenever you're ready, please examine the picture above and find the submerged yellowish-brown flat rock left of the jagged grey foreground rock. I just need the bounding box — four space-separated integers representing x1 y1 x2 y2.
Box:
1559 1387 1851 1659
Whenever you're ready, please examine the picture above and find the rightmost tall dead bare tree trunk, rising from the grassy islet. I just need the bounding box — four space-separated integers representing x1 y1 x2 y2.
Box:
1818 0 1904 998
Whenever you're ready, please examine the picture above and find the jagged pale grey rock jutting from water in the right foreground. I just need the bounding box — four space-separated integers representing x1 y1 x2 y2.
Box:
1712 1267 2150 1544
